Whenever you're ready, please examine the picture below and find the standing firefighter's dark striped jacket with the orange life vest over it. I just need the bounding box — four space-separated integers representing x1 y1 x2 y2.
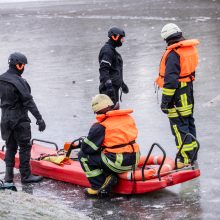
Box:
156 39 199 118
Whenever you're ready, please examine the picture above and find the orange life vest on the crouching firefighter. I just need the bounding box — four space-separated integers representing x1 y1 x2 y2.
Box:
96 109 139 153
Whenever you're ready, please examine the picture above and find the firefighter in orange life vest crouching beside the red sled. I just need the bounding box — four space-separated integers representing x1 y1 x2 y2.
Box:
78 94 140 196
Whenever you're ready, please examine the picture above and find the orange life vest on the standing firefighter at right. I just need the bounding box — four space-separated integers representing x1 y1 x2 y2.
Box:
155 39 199 88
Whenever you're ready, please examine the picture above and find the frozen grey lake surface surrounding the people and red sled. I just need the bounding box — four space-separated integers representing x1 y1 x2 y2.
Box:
0 0 220 219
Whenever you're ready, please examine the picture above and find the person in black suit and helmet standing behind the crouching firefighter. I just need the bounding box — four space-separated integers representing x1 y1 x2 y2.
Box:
99 27 129 104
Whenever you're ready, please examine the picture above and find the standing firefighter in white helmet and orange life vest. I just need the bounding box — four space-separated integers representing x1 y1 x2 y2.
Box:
155 23 199 168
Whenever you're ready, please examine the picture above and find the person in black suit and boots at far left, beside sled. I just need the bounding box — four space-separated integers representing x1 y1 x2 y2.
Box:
0 52 46 183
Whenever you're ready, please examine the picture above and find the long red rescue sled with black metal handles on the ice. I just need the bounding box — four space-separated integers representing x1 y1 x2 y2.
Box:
0 134 200 194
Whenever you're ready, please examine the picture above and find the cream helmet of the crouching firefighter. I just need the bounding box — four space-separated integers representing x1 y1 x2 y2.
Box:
91 94 114 113
